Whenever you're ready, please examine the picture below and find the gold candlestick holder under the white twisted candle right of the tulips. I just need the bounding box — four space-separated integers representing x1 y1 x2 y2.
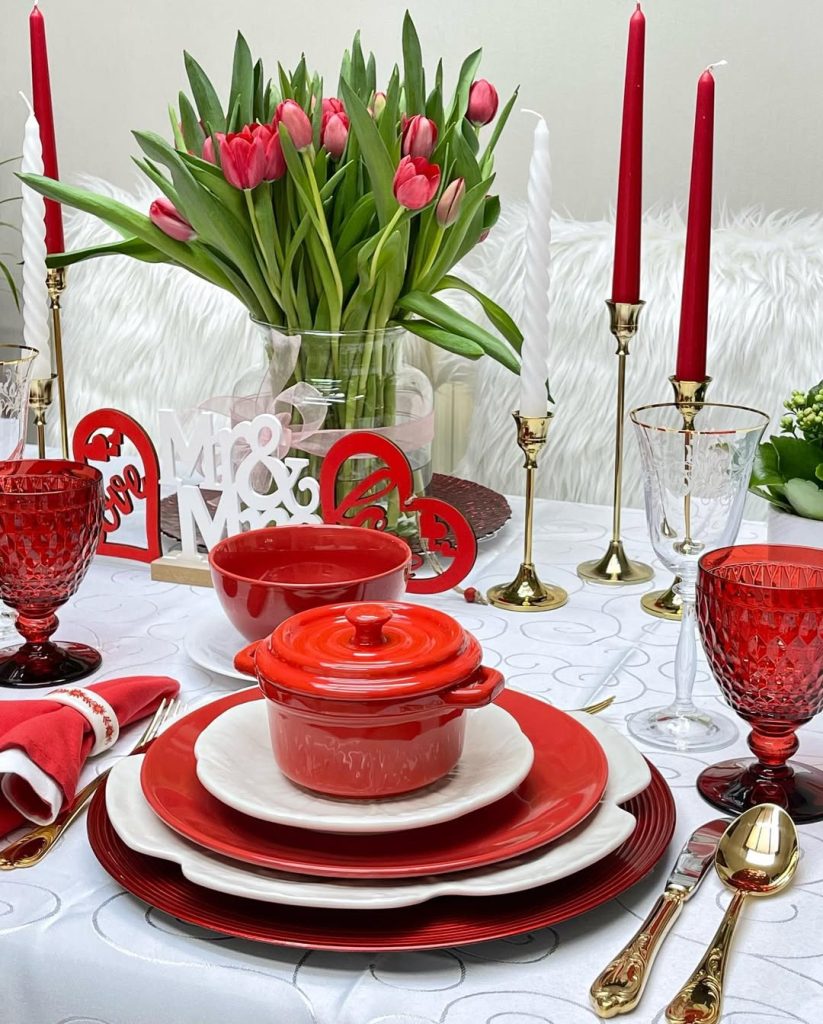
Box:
486 413 569 611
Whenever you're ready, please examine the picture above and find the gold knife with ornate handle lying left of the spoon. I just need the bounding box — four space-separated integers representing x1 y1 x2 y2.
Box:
589 818 730 1017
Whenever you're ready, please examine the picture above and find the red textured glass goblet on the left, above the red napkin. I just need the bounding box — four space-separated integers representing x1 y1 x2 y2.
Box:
0 459 103 687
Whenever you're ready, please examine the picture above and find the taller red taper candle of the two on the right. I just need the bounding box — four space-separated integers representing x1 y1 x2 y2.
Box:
611 4 646 302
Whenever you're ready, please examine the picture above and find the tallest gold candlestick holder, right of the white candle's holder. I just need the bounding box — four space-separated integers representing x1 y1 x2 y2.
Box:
577 301 654 587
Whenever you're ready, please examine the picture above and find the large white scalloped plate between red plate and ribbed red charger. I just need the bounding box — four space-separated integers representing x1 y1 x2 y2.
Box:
105 715 651 910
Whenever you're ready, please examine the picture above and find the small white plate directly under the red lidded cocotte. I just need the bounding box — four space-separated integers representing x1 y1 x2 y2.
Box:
194 700 534 834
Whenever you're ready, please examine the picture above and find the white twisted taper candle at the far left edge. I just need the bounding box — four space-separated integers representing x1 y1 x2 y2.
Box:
20 93 51 380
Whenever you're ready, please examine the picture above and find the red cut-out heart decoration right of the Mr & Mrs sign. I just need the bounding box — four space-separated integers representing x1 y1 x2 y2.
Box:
319 430 477 594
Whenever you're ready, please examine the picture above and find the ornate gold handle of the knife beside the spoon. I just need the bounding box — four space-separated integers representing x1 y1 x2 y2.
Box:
589 889 686 1017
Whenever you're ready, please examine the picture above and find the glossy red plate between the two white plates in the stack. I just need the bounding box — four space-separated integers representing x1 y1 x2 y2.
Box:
141 689 608 879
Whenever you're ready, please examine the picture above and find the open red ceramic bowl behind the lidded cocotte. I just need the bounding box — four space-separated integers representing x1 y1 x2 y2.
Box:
209 523 412 640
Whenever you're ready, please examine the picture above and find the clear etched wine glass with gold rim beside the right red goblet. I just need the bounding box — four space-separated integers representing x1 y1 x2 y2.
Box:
626 403 769 751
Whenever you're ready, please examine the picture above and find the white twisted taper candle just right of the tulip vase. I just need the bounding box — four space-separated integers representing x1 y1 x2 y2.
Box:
520 111 552 416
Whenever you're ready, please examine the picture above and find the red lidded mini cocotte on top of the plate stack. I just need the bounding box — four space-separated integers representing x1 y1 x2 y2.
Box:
241 601 504 799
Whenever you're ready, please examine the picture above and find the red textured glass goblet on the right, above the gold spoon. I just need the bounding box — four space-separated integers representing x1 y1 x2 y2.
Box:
697 544 823 822
